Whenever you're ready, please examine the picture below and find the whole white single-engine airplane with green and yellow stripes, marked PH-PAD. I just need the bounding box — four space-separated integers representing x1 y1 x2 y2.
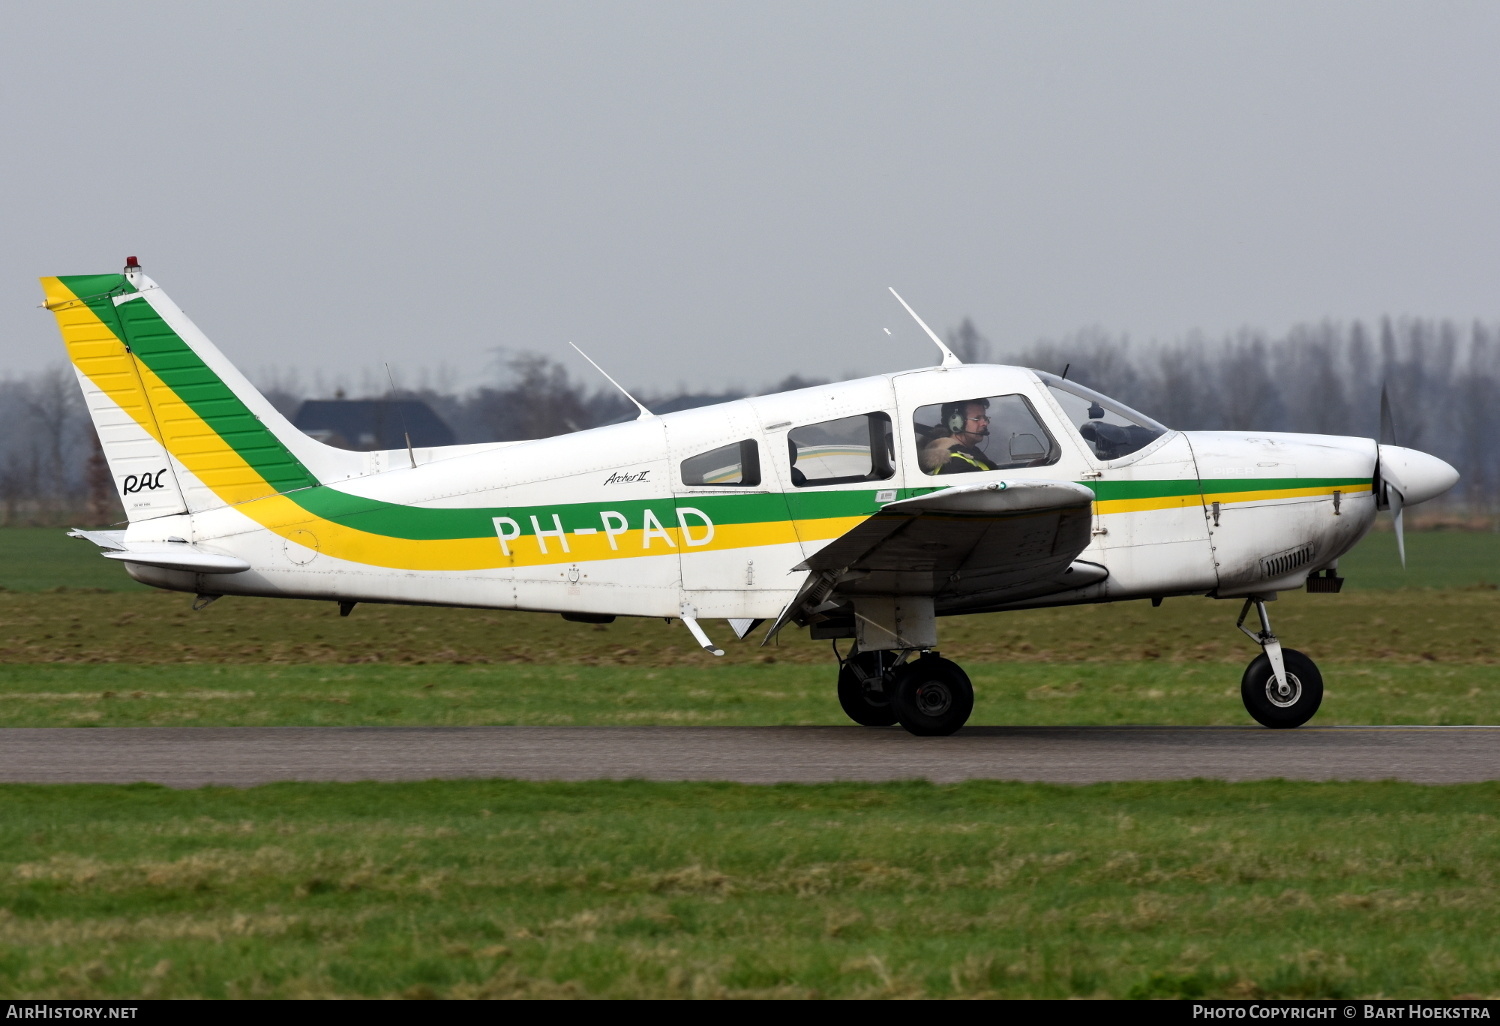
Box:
42 257 1458 735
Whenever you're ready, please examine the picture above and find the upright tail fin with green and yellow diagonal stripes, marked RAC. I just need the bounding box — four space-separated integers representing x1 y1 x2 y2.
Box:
42 257 360 521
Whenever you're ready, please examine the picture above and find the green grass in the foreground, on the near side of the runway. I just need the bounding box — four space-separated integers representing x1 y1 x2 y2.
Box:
0 782 1500 998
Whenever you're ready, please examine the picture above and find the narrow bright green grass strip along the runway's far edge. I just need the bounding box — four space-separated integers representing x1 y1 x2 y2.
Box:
0 662 1500 726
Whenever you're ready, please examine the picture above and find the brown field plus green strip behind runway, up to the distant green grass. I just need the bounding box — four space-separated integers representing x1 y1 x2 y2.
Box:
0 590 1500 726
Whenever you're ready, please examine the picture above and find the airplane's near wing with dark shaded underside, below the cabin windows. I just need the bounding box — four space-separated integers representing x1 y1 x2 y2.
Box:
767 480 1109 638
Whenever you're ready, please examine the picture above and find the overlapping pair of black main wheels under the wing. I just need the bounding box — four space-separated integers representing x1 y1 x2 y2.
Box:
834 644 974 737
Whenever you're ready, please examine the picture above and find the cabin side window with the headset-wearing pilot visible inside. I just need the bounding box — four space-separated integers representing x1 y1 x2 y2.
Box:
914 396 1061 476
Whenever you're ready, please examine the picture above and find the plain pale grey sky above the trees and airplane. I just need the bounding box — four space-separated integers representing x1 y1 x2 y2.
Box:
0 0 1500 389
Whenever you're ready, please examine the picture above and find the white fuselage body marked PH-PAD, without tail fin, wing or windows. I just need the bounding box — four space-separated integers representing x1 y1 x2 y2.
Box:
126 366 1377 618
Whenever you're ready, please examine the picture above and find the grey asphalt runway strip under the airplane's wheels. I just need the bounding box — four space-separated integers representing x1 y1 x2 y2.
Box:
0 726 1500 788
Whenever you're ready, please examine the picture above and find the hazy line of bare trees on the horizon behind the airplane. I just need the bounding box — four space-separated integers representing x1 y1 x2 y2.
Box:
0 318 1500 525
